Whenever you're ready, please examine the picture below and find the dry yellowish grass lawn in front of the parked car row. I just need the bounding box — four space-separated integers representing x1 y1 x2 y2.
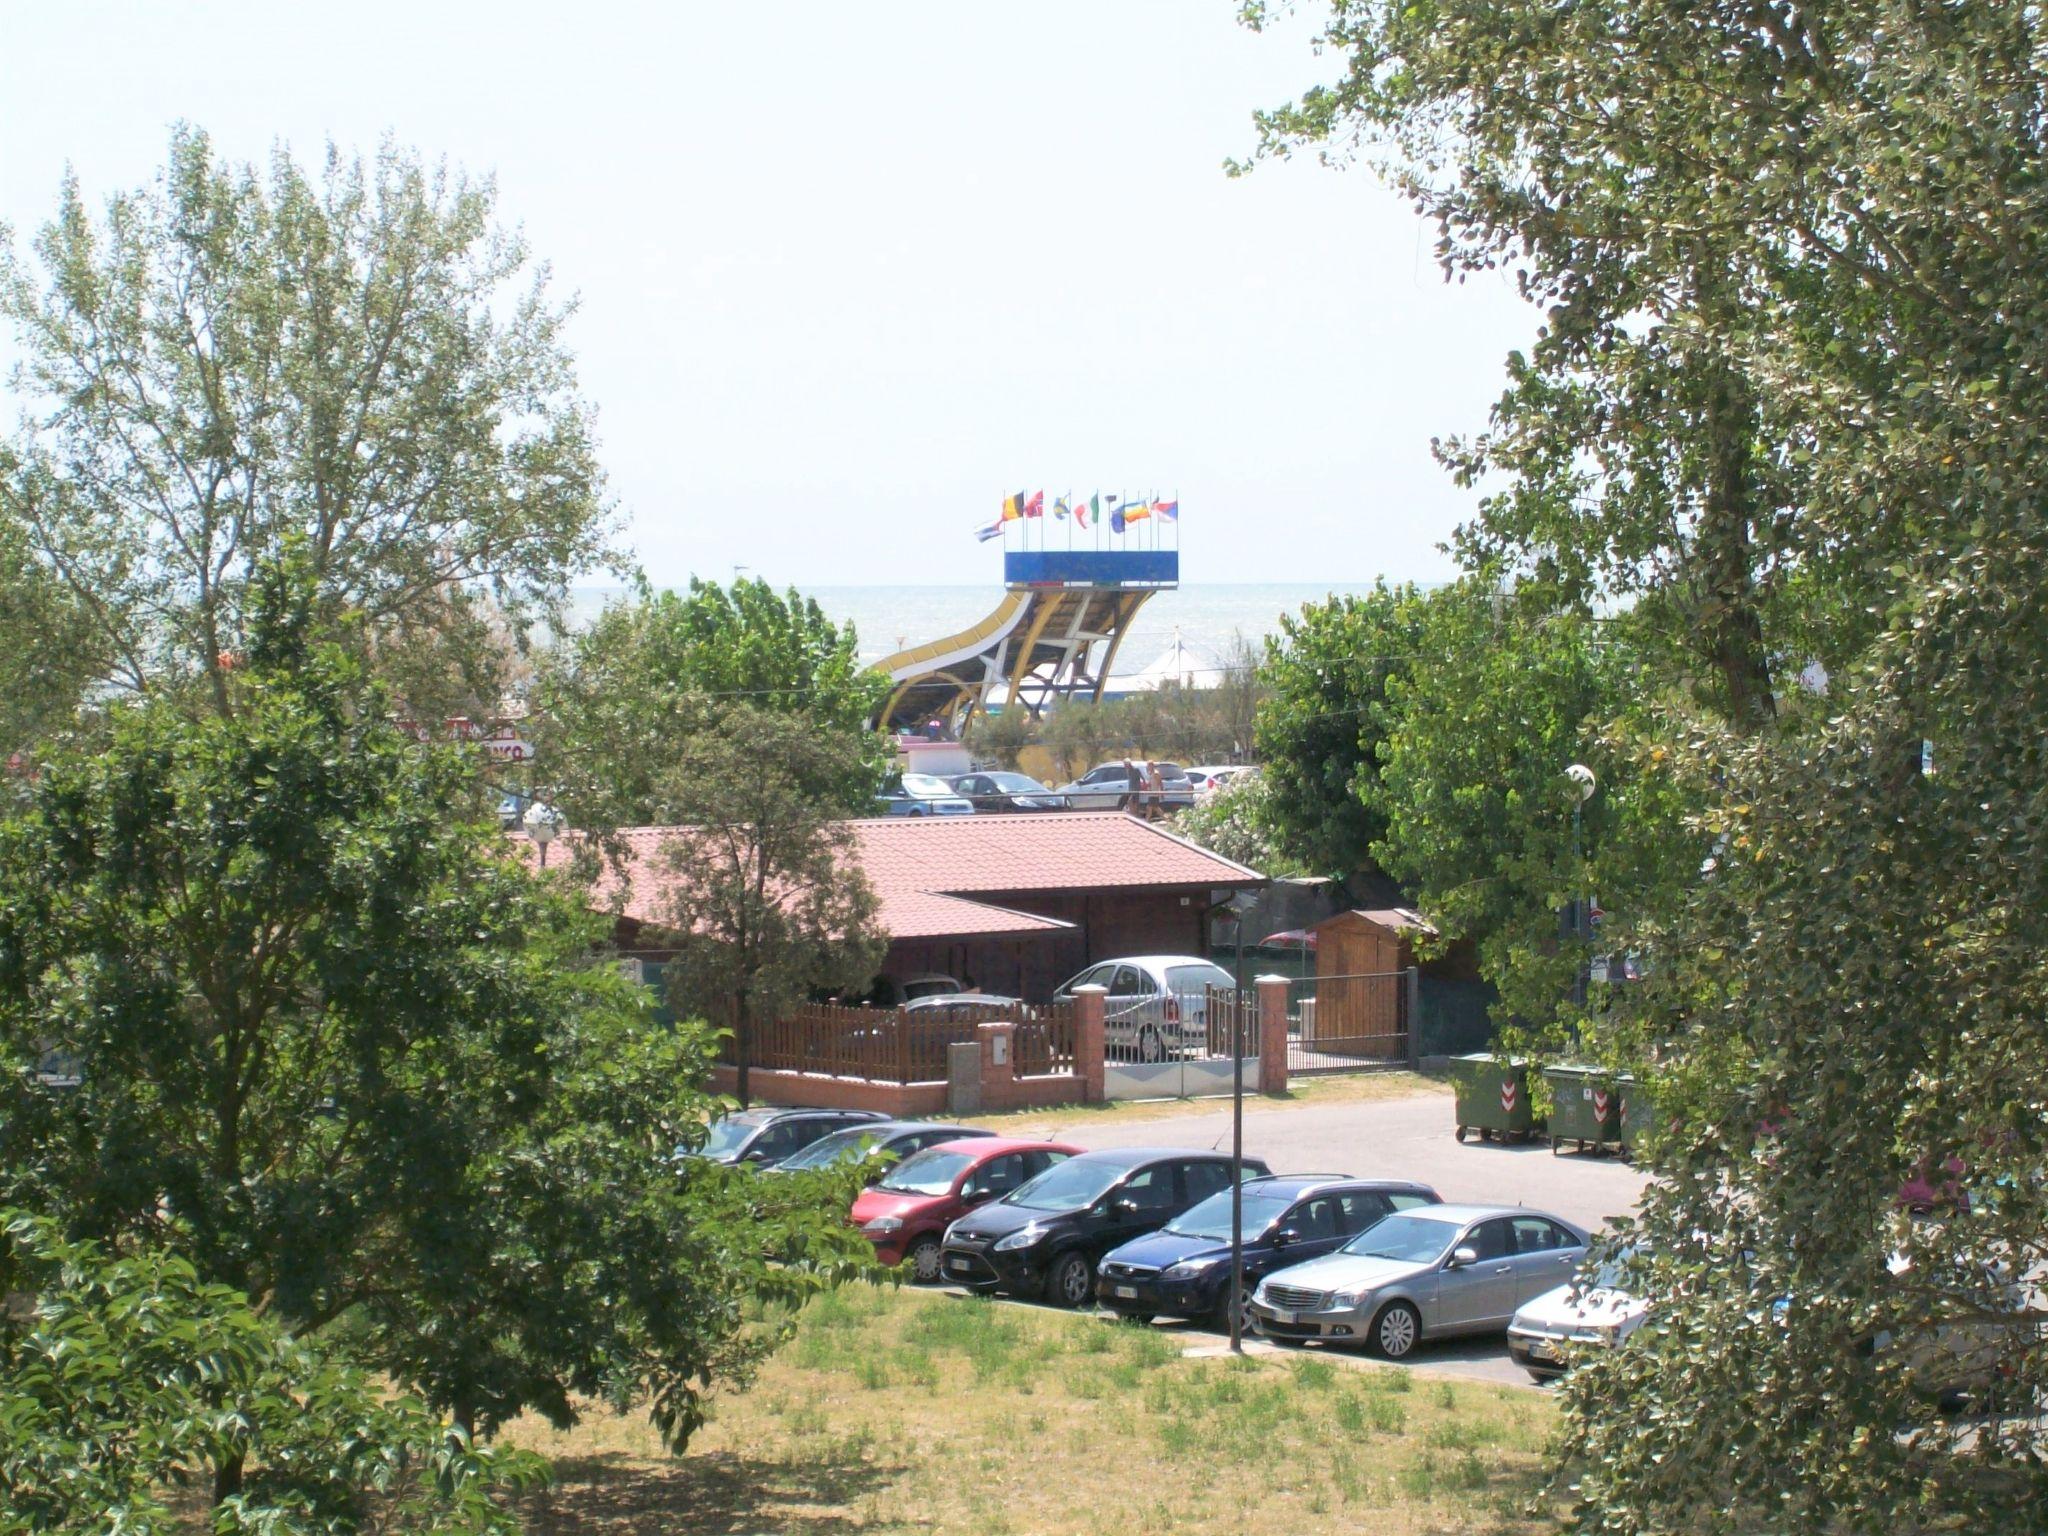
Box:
508 1286 1552 1536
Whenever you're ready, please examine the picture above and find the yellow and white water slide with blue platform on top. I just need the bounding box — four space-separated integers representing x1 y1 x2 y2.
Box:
877 549 1180 733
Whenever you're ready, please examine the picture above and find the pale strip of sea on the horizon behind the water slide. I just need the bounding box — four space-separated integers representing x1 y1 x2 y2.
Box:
573 582 1370 676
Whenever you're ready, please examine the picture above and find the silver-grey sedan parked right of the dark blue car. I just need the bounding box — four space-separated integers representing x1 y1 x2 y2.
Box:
1251 1206 1587 1360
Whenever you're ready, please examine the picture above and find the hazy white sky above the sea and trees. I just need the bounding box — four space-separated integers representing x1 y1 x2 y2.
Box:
0 0 1534 586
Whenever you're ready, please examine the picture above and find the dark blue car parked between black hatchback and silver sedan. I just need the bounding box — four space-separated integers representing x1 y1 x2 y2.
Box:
1096 1174 1438 1333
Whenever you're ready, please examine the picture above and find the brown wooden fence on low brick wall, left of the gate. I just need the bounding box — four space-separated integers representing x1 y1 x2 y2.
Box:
723 1004 1075 1083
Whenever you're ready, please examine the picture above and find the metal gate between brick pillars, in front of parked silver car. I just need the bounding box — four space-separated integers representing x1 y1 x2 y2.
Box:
1102 977 1260 1098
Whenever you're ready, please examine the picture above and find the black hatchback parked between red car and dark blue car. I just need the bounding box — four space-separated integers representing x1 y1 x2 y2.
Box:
940 1147 1268 1307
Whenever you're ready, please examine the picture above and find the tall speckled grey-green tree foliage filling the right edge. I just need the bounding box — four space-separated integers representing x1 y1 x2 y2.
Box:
1253 0 2048 1532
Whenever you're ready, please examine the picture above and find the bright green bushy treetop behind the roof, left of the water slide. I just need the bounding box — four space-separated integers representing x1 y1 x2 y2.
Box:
532 578 891 834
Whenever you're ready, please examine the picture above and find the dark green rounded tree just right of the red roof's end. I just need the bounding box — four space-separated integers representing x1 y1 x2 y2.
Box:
1255 584 1421 874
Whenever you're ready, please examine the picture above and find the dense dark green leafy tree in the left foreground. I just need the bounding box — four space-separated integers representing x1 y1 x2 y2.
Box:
0 565 870 1495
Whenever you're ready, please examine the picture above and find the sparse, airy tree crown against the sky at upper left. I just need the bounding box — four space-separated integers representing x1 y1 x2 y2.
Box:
0 127 608 707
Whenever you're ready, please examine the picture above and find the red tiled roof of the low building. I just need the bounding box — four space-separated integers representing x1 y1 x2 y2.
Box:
518 811 1266 938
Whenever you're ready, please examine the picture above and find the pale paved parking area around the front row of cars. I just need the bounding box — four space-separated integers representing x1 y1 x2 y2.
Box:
974 1092 1649 1386
